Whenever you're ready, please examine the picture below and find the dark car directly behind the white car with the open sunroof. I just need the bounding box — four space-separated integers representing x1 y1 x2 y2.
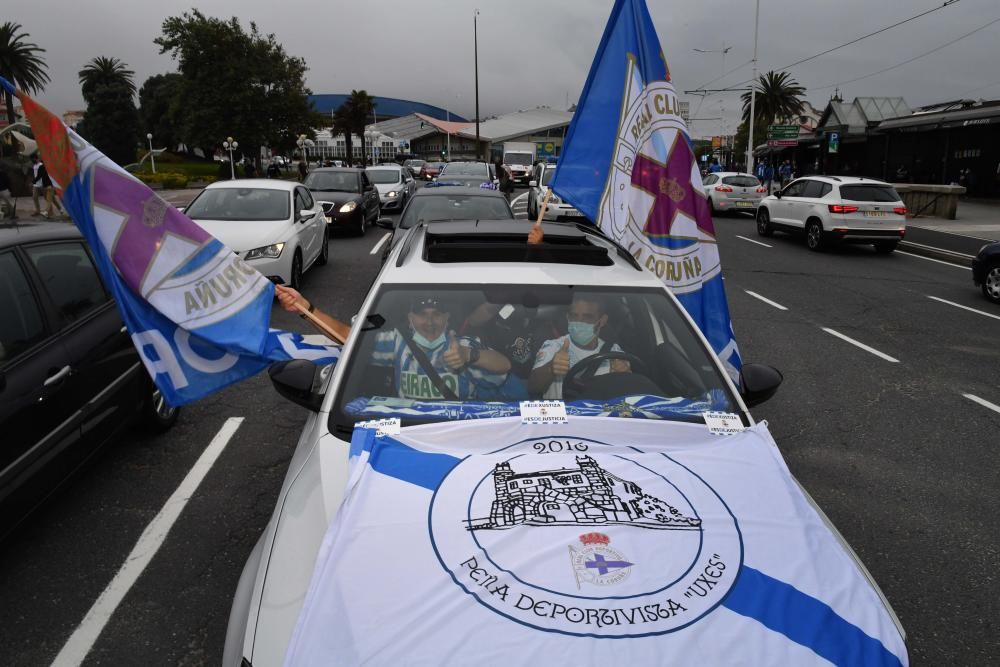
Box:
382 183 512 263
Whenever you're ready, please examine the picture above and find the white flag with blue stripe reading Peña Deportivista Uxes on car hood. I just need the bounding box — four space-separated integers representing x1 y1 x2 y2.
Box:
285 417 908 667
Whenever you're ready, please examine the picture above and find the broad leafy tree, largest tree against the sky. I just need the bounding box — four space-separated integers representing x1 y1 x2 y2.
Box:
154 9 327 163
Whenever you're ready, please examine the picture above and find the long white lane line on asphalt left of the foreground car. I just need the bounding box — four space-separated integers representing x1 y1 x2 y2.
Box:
52 417 243 667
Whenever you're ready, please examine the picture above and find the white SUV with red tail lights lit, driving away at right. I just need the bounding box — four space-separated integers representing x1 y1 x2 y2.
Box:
757 176 906 253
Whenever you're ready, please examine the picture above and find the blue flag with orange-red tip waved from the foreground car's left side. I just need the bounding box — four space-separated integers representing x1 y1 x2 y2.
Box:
0 78 340 406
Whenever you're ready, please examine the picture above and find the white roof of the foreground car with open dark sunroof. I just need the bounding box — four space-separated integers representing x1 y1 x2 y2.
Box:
379 220 652 289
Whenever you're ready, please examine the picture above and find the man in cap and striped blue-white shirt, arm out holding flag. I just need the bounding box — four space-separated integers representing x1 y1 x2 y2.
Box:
276 286 511 401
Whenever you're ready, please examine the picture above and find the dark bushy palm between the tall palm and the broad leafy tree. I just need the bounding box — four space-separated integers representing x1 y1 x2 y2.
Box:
77 56 139 165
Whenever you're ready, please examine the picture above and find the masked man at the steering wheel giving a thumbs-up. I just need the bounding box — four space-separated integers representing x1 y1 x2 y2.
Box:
528 294 630 399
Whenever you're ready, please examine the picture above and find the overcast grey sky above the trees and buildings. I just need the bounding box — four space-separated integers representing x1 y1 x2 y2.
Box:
2 0 1000 136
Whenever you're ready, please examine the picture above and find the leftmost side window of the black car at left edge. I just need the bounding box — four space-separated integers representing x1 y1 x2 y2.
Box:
0 251 45 368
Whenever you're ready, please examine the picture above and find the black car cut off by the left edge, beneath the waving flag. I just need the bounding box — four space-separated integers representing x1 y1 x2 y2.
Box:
0 222 178 535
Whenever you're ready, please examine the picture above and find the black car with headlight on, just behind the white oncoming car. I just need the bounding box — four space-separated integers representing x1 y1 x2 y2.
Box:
305 167 382 236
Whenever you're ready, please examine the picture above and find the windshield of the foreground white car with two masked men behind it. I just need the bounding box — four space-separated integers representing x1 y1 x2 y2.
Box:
330 284 741 434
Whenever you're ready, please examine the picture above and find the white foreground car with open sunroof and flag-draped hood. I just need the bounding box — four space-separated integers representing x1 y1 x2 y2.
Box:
223 220 908 667
